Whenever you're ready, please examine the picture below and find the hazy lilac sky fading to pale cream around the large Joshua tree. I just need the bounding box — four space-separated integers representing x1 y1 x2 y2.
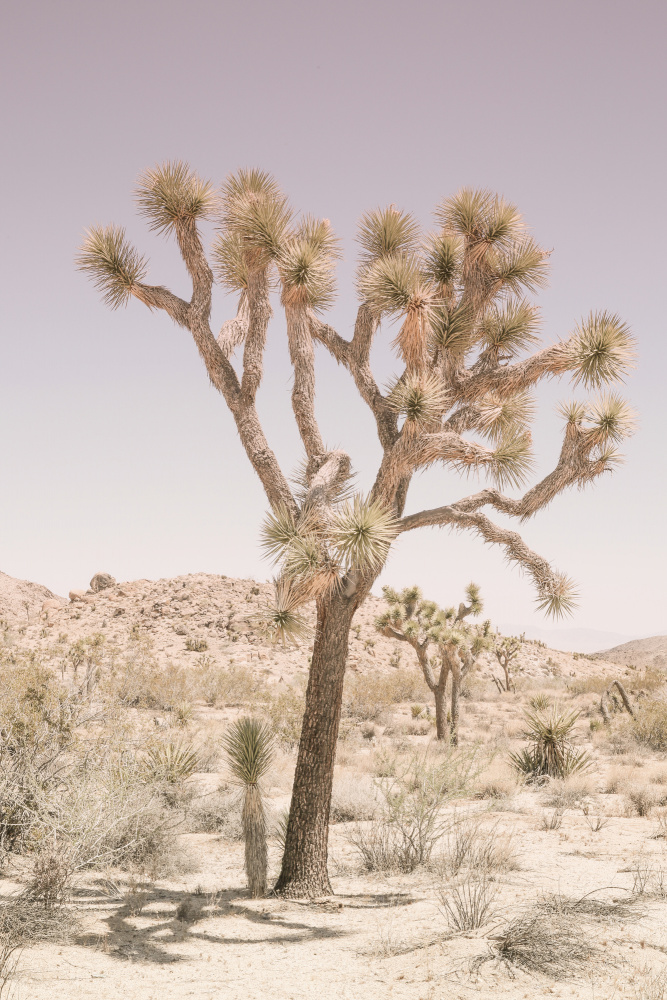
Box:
0 0 667 633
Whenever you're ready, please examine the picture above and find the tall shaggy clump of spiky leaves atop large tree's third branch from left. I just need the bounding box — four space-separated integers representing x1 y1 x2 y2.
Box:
222 170 293 267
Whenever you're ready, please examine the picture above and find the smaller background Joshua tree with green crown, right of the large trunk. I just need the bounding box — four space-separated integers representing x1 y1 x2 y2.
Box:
375 583 491 744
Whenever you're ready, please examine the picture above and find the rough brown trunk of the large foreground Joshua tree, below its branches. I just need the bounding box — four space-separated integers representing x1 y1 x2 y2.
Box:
275 594 357 896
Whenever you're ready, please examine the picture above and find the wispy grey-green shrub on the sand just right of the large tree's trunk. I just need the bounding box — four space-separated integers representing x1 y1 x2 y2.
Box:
348 749 479 872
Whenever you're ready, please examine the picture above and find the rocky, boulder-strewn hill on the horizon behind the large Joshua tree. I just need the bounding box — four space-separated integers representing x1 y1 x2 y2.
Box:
0 573 648 680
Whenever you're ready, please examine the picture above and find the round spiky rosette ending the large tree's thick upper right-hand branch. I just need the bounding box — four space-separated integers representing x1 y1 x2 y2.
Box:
566 312 637 388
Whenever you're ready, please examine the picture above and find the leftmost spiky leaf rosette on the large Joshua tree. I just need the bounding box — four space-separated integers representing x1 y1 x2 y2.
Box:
76 226 148 309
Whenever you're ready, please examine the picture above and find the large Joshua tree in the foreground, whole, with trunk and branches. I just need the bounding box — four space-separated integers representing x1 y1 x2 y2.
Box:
78 163 634 895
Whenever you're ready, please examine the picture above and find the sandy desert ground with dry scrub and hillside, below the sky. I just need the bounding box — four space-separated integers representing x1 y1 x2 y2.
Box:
0 578 667 1000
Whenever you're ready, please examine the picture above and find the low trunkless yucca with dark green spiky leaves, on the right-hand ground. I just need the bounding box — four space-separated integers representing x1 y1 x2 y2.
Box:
509 706 593 780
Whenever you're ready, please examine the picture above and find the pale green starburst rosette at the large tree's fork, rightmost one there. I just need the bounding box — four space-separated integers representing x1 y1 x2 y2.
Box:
329 496 398 572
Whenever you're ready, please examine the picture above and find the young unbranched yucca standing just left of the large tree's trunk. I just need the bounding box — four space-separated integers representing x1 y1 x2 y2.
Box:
222 718 275 897
